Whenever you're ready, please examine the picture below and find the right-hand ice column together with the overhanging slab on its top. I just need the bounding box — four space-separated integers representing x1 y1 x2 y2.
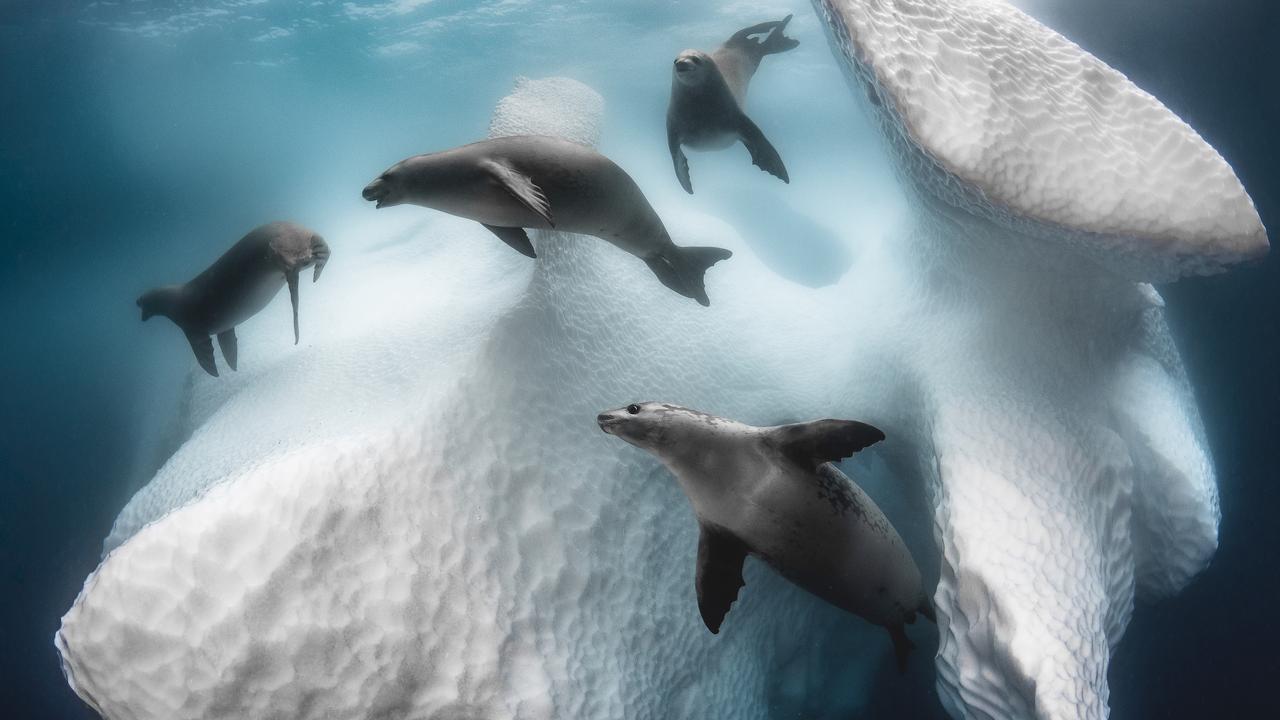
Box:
814 0 1268 720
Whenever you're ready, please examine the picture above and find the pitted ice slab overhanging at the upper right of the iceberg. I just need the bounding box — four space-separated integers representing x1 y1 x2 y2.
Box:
814 0 1268 281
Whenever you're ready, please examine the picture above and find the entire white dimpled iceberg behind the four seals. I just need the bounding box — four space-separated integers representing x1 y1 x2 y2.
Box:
56 0 1267 720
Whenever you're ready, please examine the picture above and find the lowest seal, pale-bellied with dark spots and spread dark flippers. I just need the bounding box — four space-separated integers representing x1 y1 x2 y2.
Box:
596 402 933 670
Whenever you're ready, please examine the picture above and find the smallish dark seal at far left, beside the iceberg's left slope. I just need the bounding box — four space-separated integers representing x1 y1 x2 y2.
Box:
138 223 329 378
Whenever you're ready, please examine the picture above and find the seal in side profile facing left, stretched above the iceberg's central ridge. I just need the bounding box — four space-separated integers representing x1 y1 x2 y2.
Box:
362 136 733 306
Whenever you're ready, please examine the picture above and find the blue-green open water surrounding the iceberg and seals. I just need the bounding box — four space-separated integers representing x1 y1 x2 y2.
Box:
0 0 1280 717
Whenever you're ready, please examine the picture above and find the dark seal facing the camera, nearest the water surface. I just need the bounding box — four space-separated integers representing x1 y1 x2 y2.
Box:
667 15 800 195
